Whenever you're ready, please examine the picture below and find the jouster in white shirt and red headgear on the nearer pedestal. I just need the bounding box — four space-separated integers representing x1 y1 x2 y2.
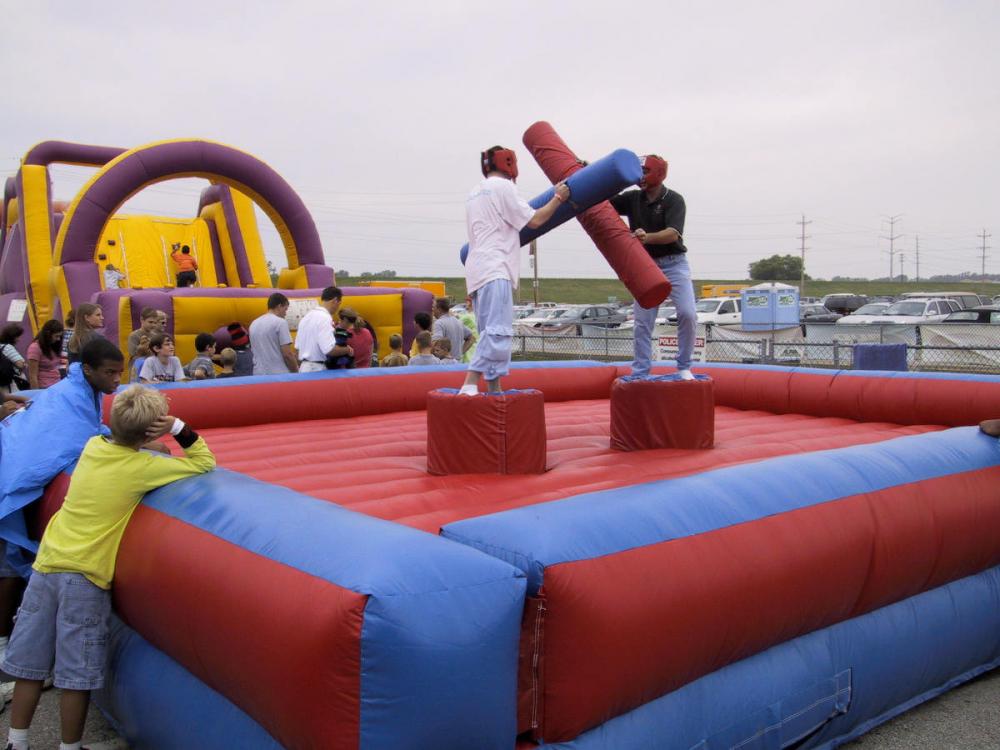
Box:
460 146 569 396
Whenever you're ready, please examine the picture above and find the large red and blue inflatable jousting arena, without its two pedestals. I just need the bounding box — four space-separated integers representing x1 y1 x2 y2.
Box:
86 362 1000 750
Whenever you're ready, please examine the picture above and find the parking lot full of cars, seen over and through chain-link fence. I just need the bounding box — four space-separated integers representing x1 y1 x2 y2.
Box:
514 298 1000 374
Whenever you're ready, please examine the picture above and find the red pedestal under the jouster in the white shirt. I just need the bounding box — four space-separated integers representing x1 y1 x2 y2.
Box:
427 389 545 474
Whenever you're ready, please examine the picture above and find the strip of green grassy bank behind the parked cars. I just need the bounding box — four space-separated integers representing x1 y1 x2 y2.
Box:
337 276 1000 304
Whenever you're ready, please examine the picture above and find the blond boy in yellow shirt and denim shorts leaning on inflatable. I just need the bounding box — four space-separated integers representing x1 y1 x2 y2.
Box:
3 385 215 750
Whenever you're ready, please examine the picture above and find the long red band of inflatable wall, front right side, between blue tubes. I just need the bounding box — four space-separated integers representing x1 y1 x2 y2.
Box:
519 467 1000 742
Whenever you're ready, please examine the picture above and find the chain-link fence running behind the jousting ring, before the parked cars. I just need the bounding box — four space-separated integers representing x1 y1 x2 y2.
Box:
514 323 1000 374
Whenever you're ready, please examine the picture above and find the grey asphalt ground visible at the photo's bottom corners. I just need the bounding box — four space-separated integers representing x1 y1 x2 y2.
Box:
0 669 1000 750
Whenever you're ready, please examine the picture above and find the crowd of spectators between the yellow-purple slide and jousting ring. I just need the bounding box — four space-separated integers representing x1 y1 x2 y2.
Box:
0 287 477 402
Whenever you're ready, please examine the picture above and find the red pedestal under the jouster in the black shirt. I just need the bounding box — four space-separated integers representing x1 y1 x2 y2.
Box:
611 375 715 451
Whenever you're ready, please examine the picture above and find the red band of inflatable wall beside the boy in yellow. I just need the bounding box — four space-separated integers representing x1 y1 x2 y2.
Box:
114 505 367 750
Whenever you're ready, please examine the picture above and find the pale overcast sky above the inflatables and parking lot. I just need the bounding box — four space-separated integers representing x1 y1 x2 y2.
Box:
0 0 1000 278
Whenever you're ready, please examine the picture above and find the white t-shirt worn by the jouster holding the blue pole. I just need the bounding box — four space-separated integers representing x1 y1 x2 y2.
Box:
465 177 535 294
